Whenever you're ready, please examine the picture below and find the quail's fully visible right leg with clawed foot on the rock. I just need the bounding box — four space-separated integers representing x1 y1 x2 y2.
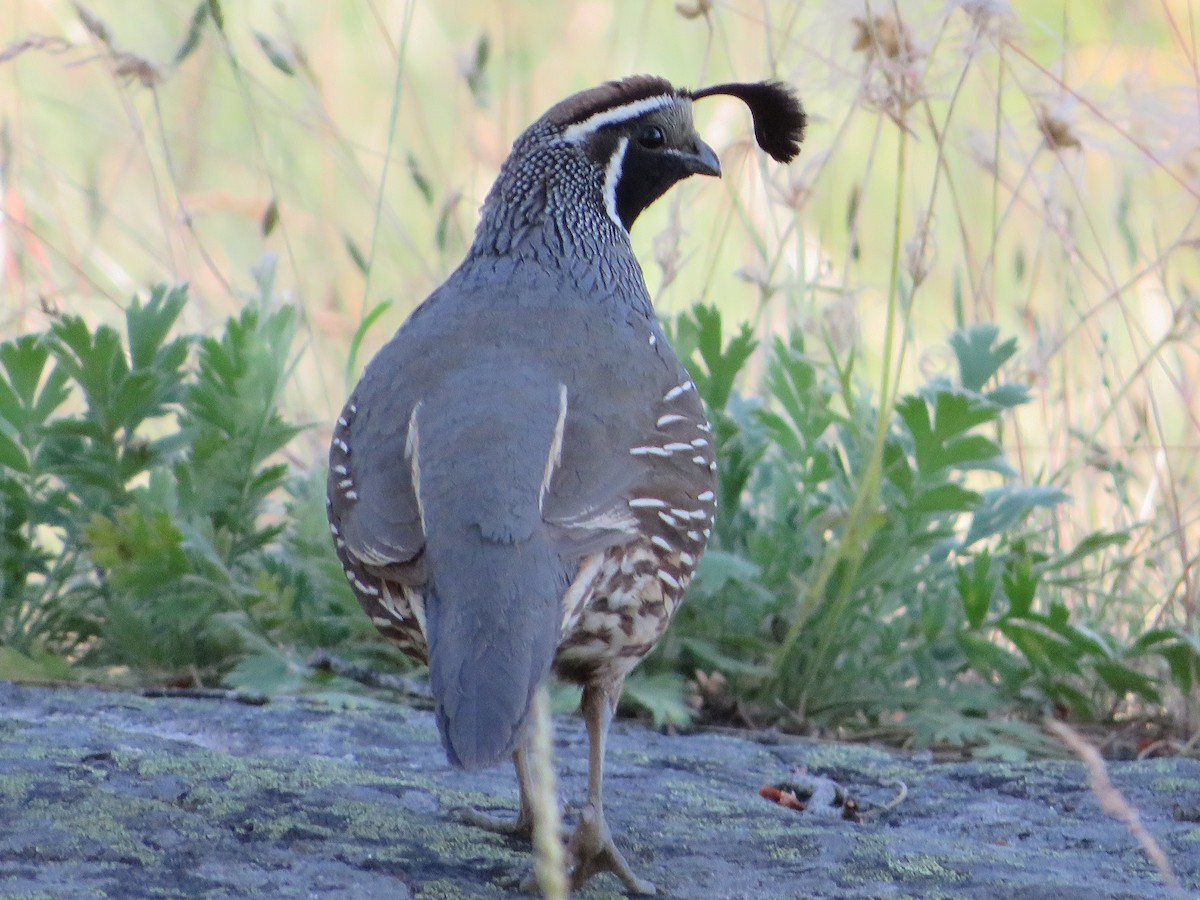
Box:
568 679 655 894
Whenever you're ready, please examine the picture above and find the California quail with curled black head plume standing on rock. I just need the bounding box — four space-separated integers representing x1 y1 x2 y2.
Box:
328 76 805 892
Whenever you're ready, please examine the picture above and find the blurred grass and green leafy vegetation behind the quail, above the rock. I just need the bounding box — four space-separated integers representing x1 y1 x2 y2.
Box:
0 0 1200 754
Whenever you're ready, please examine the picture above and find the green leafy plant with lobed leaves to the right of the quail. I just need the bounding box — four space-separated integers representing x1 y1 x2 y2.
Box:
649 307 1200 758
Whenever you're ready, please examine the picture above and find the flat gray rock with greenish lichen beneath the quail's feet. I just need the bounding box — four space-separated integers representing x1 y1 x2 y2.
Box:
0 683 1200 900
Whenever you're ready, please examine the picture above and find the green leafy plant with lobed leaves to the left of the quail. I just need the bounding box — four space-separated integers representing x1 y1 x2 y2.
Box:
0 278 384 689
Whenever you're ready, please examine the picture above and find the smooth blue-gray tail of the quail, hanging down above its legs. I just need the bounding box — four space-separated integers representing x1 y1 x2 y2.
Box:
425 526 566 769
